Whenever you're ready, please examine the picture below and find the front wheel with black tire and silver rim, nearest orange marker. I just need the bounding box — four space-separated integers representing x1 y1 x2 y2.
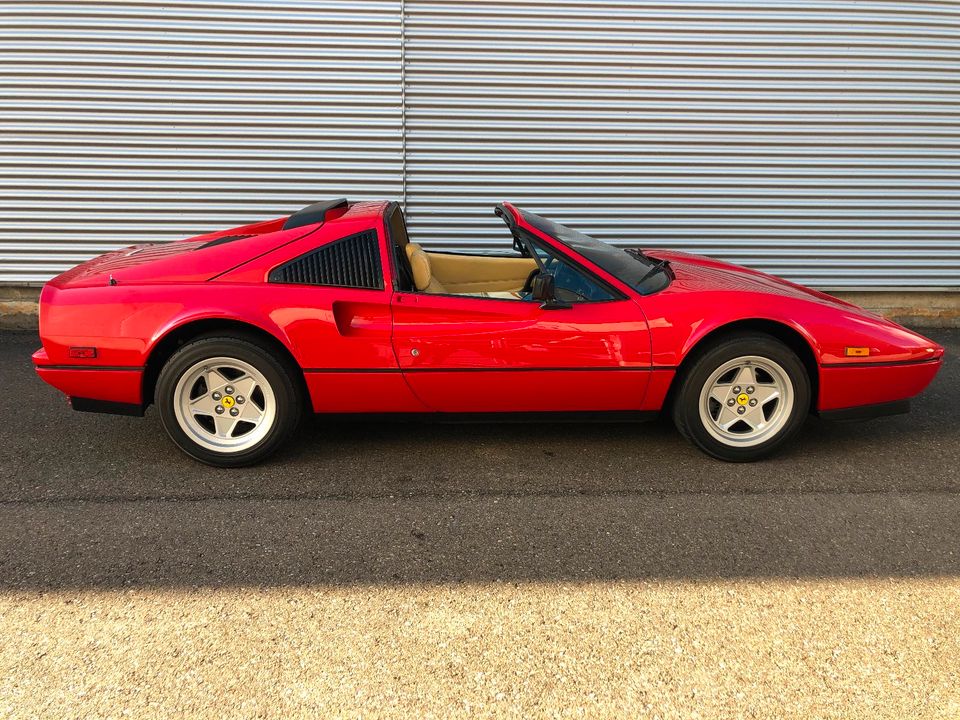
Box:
673 335 810 462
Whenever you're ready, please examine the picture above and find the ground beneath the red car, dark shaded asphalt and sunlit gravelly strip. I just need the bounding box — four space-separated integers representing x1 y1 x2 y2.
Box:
0 331 960 717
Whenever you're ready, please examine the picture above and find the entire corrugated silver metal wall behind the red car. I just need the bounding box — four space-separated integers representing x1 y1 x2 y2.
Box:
0 0 960 288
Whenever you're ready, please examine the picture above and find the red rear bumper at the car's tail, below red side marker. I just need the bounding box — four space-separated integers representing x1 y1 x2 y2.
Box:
33 350 144 415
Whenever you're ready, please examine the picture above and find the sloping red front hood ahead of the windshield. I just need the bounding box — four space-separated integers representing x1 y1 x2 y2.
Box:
643 250 879 318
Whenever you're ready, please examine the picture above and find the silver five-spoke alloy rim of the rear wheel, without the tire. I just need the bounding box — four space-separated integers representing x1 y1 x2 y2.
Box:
173 357 277 453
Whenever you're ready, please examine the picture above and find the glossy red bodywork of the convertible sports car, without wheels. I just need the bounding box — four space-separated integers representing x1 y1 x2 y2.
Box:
33 202 943 416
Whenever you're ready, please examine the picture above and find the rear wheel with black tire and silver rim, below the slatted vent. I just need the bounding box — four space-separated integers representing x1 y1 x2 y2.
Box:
156 337 302 467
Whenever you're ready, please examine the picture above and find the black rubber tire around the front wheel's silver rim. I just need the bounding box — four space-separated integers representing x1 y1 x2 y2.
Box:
672 334 810 462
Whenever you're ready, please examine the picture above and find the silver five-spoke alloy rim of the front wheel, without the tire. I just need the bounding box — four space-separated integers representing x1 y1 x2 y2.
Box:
700 355 794 447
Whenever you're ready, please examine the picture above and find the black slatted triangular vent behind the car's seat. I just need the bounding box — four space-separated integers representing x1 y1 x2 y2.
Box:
268 230 383 290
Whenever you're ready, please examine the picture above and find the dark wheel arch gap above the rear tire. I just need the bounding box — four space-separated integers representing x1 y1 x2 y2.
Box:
142 317 310 407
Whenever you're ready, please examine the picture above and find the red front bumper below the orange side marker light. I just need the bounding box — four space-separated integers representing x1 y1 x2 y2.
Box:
817 357 943 417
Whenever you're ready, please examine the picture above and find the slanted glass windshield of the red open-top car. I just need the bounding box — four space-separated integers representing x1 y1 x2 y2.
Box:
517 208 670 295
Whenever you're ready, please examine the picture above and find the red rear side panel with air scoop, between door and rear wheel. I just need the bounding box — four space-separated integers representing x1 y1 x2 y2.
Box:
225 217 428 413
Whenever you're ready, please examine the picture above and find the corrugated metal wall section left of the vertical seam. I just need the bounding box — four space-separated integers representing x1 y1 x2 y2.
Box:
0 0 402 283
